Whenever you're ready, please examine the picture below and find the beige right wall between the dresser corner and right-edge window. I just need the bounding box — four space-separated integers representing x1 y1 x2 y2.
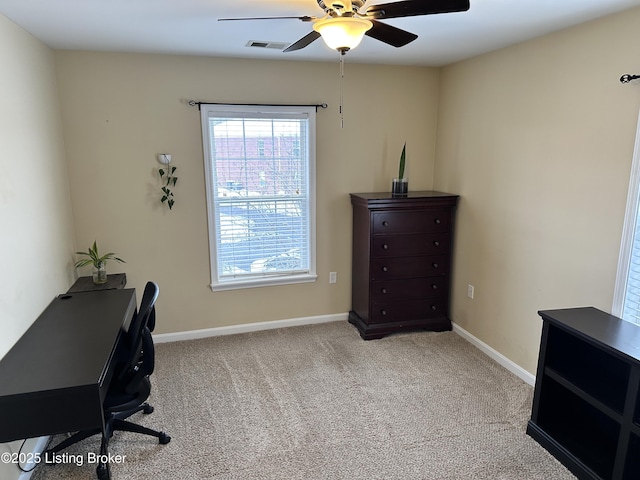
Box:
435 9 640 373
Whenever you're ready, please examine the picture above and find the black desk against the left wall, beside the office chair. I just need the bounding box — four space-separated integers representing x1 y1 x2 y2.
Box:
0 289 136 442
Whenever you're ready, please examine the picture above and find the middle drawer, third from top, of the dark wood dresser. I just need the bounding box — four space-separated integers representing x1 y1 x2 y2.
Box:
370 255 449 281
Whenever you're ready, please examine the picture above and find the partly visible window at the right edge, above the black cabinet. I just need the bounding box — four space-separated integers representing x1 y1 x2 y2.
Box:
612 110 640 324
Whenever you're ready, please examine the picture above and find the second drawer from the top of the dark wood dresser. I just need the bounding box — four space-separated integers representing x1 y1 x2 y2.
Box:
371 232 451 257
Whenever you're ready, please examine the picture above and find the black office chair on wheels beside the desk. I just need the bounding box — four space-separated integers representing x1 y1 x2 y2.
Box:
46 282 171 480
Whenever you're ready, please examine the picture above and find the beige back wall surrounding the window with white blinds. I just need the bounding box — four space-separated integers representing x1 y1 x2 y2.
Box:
56 52 438 332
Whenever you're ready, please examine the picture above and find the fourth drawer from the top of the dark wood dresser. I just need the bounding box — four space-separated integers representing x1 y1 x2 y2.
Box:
371 276 449 302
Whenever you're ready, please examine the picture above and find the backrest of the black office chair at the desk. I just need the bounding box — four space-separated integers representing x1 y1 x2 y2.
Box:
116 282 160 390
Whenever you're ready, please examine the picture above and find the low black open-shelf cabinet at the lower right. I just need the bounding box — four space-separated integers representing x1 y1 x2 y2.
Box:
527 307 640 480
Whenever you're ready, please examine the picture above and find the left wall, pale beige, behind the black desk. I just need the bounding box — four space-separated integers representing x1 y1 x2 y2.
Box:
0 15 75 360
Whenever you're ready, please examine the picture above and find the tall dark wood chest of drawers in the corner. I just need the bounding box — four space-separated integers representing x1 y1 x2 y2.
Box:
349 191 458 340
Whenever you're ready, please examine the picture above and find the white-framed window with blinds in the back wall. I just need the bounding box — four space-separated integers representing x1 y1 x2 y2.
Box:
201 105 316 290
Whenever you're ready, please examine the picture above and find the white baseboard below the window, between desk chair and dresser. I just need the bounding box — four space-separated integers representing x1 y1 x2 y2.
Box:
153 313 349 343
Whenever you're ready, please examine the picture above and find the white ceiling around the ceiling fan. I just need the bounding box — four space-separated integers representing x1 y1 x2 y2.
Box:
0 0 640 66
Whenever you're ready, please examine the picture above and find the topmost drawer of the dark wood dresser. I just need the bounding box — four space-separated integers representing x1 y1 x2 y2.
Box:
372 209 451 234
